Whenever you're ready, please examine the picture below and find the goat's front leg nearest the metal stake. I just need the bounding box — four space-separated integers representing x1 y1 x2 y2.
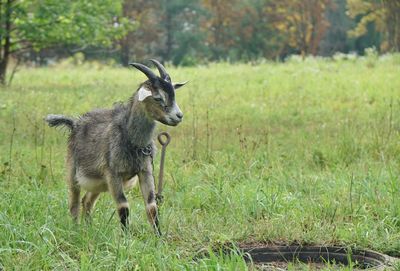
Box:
139 158 161 236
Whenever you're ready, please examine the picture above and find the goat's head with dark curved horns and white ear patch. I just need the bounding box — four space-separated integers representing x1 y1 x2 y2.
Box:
129 59 186 126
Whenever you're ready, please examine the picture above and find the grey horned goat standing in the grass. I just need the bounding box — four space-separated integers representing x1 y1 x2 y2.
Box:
45 59 187 235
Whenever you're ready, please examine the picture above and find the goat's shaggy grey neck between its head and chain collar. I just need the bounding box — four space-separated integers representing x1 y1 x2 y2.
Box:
128 97 156 147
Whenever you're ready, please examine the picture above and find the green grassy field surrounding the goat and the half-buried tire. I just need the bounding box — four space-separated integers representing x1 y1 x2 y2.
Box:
0 55 400 270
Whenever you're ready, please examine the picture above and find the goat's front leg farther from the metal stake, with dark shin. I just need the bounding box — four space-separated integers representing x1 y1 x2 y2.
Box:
107 173 129 230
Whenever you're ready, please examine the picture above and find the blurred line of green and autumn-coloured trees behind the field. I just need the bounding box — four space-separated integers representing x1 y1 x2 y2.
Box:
0 0 400 83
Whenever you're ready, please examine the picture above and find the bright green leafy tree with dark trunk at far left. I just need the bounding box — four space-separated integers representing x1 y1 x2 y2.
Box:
0 0 132 84
